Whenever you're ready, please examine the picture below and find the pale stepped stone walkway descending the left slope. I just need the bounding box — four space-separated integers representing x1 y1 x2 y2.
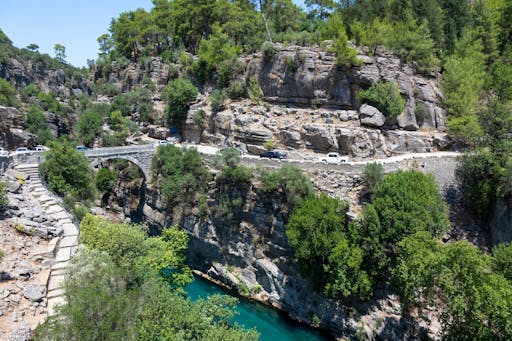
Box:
15 164 79 316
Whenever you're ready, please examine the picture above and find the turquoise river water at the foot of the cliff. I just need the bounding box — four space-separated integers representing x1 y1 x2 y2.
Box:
185 277 330 341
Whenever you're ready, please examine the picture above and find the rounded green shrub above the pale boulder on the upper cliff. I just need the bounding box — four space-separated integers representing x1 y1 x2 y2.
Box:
359 82 405 117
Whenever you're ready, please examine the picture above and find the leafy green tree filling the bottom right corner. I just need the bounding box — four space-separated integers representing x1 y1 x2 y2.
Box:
394 232 512 340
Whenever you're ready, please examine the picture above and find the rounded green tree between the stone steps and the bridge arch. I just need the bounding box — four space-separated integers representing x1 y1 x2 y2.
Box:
40 140 94 200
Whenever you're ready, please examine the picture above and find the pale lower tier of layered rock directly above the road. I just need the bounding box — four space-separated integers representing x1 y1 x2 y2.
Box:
198 100 451 159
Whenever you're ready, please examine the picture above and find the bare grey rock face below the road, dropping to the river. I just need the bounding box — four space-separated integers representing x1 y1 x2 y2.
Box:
134 158 456 339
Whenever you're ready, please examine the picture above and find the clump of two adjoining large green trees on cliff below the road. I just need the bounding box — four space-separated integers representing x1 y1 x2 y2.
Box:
286 168 449 298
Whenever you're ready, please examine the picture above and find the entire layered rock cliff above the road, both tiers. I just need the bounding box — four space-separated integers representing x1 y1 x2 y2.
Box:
185 45 451 158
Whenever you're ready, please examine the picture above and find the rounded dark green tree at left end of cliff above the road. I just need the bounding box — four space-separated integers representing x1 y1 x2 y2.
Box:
165 78 198 125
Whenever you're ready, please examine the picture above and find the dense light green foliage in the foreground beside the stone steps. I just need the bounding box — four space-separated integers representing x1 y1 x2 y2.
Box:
35 215 258 341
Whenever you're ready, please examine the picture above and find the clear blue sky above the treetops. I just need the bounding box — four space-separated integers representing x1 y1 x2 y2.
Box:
0 0 303 67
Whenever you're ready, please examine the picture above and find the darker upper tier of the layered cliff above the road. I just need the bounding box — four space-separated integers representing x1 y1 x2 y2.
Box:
245 44 445 130
